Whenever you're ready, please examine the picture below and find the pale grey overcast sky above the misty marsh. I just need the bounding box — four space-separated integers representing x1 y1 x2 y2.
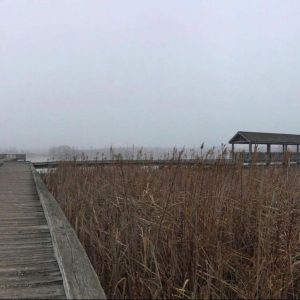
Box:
0 0 300 149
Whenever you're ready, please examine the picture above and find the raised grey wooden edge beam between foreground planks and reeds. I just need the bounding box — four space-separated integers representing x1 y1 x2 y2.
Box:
31 165 106 299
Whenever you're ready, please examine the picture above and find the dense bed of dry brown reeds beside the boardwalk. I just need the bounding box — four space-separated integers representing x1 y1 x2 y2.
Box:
45 161 300 299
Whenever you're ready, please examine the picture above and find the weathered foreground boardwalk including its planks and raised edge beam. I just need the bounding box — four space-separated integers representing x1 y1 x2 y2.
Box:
0 162 105 299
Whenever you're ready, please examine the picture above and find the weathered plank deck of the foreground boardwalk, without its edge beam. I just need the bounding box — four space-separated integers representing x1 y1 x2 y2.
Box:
0 162 65 299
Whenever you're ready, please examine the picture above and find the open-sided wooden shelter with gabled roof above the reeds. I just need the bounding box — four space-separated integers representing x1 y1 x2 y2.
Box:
229 131 300 161
